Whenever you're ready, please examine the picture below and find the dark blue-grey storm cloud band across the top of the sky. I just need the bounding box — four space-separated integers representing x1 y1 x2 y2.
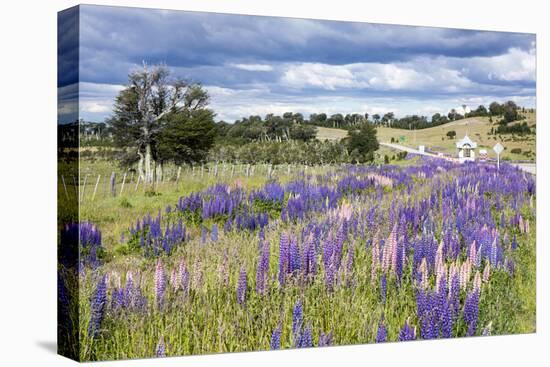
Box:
77 6 532 82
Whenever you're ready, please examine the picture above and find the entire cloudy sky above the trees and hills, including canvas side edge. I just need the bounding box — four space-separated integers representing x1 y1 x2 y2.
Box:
58 5 536 122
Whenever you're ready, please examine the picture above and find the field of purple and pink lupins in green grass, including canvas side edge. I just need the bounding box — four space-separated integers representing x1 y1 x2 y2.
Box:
59 159 536 360
